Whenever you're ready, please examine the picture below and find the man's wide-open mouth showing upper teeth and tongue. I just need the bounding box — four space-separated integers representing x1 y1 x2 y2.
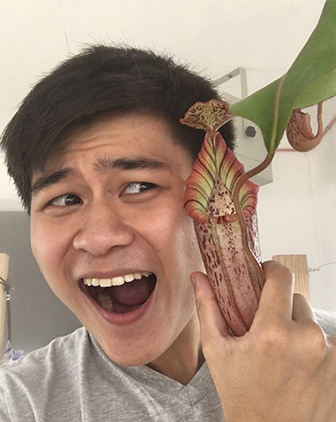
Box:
81 272 156 313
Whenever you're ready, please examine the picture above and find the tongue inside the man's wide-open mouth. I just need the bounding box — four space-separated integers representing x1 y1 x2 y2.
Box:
111 277 155 306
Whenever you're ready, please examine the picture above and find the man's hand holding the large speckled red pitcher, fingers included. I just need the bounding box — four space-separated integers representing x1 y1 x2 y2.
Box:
192 261 336 422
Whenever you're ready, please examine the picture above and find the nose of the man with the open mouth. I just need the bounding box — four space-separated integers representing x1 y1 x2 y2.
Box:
73 203 134 256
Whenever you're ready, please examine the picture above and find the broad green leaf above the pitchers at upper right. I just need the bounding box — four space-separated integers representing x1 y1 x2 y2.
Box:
230 0 336 153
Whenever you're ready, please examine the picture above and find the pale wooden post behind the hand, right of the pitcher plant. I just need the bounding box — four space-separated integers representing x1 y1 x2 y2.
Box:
272 255 310 300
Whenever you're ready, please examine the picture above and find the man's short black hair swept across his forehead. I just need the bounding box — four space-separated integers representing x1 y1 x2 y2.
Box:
1 45 234 212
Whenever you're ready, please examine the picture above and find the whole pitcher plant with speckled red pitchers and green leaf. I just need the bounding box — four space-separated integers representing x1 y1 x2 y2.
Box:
181 0 336 335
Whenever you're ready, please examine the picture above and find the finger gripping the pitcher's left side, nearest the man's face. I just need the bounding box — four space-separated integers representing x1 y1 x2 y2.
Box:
191 271 231 341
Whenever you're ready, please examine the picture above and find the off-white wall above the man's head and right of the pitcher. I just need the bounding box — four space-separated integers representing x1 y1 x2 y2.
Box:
0 0 336 310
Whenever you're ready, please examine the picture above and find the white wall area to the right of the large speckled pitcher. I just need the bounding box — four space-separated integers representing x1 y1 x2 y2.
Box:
258 98 336 311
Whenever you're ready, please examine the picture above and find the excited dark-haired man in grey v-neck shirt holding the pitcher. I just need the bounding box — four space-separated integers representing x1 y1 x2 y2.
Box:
0 46 336 422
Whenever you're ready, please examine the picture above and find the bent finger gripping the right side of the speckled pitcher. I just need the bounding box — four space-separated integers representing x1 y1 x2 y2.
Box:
259 261 294 319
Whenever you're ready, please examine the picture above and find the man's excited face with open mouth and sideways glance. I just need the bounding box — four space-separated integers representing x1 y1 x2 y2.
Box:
31 114 204 365
